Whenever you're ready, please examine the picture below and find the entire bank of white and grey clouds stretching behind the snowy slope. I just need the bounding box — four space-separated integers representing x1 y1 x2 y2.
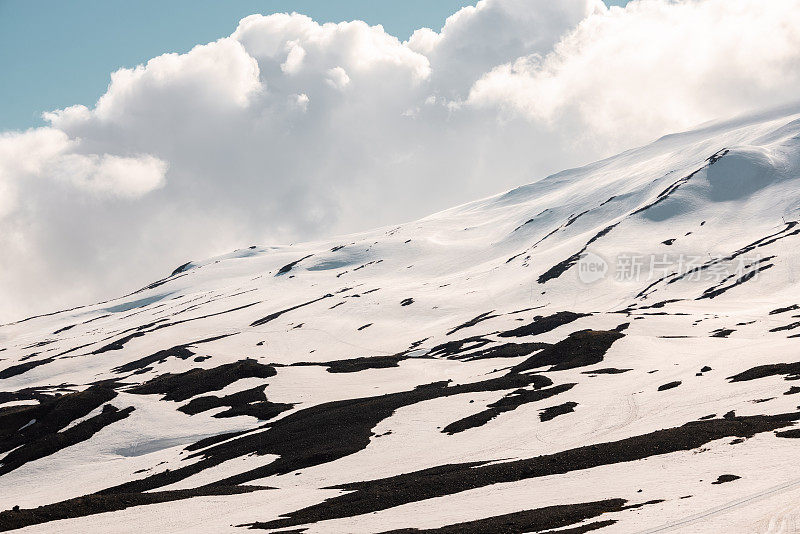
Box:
0 0 800 320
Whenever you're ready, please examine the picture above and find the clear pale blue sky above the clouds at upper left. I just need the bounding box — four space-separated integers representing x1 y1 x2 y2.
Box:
0 0 627 131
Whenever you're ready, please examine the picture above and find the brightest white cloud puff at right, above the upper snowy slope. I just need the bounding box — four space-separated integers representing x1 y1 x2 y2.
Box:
468 0 800 152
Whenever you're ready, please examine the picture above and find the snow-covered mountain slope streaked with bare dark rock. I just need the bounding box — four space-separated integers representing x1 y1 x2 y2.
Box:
0 102 800 533
